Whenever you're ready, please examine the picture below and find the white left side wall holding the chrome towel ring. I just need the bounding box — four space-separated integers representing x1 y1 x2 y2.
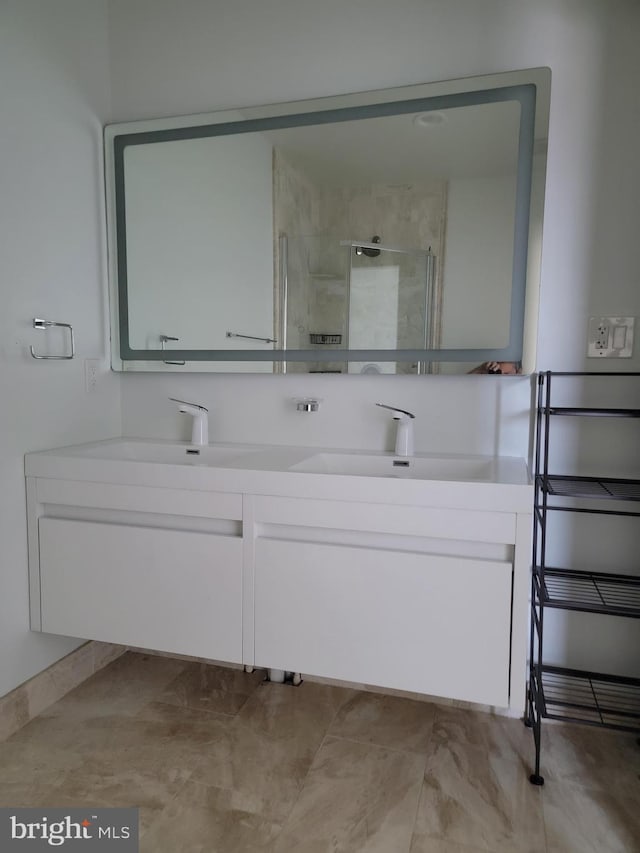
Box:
0 0 121 696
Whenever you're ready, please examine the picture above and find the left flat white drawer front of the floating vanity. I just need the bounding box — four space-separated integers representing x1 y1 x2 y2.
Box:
39 518 242 663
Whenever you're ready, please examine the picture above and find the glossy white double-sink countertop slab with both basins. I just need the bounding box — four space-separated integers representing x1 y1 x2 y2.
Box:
25 438 533 513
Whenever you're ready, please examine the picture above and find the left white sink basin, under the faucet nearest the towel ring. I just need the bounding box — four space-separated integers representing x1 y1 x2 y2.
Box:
46 439 256 466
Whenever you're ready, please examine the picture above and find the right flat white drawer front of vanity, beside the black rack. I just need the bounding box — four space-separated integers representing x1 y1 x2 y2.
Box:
255 538 512 707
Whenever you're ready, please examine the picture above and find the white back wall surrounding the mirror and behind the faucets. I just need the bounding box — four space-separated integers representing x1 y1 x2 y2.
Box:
109 0 640 672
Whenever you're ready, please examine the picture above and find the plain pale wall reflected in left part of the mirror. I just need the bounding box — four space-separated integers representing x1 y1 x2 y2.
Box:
124 133 273 356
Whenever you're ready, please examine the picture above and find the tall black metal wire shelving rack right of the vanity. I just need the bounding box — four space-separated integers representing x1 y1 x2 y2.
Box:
525 371 640 785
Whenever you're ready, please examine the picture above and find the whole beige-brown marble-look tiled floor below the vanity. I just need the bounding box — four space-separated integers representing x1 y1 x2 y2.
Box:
0 653 640 853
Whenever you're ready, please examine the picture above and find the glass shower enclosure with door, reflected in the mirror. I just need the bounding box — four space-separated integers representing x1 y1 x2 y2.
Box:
277 235 441 373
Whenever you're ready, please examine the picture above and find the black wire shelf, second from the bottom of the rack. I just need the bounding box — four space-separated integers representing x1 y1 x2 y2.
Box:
536 568 640 618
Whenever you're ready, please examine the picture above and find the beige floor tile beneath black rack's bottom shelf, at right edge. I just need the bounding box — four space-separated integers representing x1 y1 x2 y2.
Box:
540 722 640 802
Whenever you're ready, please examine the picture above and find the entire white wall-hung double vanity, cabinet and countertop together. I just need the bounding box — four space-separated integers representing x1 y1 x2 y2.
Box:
26 440 531 715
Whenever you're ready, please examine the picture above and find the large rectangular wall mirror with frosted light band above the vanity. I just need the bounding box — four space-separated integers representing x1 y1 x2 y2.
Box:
105 69 550 374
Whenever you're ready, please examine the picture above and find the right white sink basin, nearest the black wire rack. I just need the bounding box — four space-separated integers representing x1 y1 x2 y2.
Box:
289 453 495 482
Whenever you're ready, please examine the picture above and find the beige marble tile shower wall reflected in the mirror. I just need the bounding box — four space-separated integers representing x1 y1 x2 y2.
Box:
274 151 447 371
